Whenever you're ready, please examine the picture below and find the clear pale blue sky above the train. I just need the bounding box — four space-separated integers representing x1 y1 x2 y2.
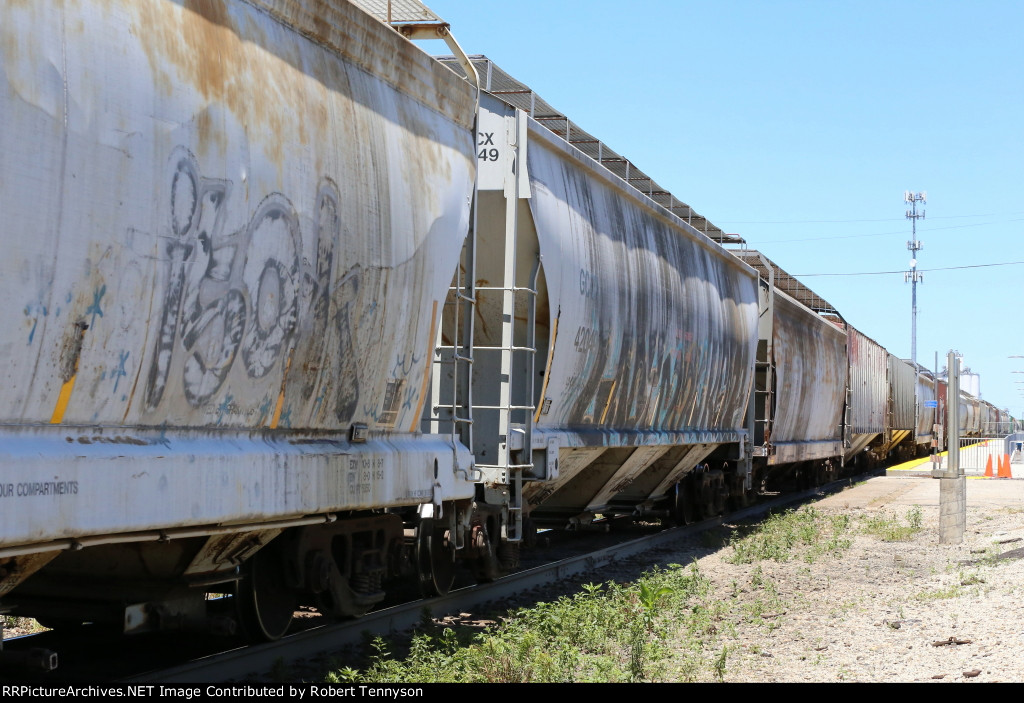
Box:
417 0 1024 416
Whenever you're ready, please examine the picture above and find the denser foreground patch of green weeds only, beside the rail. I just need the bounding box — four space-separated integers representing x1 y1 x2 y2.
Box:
327 564 745 684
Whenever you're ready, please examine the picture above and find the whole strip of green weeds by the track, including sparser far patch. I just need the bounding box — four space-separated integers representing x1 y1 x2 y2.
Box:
327 507 864 684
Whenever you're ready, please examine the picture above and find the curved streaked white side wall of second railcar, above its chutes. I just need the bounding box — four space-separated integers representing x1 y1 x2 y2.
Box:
528 125 758 445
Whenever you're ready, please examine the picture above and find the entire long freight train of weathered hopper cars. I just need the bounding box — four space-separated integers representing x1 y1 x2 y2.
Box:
0 0 1015 663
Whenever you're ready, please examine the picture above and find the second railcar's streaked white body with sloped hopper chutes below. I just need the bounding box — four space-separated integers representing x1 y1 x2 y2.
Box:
497 97 758 524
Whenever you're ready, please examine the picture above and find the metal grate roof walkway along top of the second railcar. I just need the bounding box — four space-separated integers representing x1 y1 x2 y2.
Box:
437 54 743 244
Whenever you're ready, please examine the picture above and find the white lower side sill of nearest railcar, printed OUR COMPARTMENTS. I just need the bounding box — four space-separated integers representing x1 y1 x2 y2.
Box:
0 430 472 550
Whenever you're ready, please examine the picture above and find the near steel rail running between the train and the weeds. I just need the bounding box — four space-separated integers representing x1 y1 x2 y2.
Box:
116 477 862 684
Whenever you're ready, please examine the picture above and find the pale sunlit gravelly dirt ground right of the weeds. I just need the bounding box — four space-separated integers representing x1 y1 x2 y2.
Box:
669 476 1024 682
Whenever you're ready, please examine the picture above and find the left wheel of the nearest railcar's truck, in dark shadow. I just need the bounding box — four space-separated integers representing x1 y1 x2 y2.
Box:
234 542 298 642
